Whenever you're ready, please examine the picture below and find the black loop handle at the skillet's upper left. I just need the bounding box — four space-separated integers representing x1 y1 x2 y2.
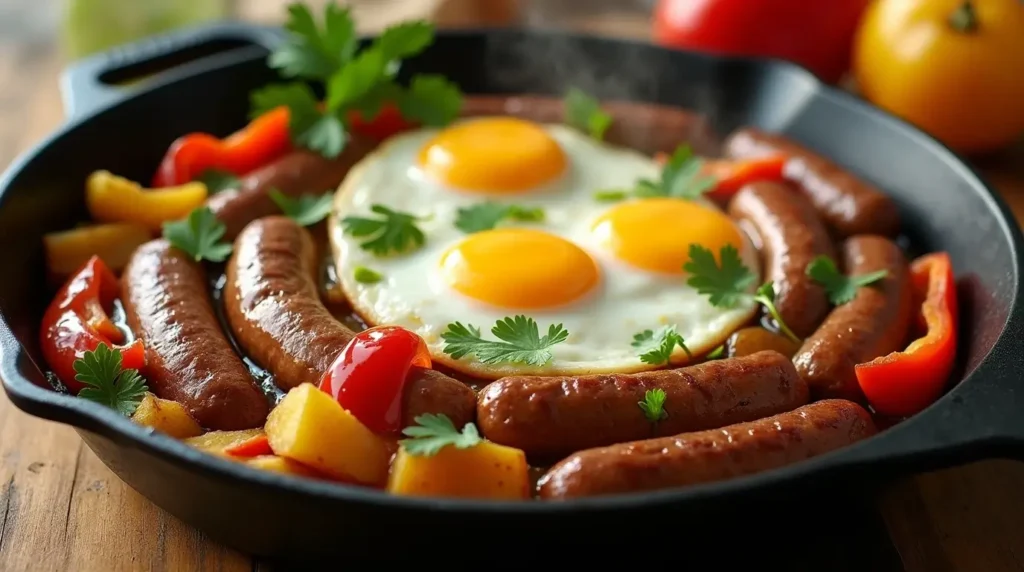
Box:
60 21 284 120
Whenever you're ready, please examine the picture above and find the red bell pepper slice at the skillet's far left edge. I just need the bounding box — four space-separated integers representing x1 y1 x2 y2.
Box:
40 256 145 395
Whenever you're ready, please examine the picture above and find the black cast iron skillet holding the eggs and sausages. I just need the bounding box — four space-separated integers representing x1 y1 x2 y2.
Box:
0 25 1024 560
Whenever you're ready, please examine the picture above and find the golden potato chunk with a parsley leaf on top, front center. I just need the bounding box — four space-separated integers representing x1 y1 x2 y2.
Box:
387 441 529 500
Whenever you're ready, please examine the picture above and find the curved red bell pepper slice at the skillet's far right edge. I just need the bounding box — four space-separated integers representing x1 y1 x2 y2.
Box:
855 253 956 416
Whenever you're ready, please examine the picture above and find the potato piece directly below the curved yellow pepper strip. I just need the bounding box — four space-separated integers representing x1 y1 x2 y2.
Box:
43 223 153 279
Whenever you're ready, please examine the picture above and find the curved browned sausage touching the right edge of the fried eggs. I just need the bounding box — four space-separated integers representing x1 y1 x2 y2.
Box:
729 181 836 338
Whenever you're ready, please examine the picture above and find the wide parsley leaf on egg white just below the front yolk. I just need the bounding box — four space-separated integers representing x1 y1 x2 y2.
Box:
441 315 569 365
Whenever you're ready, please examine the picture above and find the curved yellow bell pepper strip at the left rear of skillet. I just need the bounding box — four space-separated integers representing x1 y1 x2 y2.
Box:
85 171 208 231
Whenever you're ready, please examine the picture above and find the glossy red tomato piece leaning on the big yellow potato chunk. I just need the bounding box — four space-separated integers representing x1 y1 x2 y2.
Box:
319 325 430 433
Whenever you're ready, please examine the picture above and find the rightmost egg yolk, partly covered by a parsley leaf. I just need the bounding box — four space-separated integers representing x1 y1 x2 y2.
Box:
593 197 742 274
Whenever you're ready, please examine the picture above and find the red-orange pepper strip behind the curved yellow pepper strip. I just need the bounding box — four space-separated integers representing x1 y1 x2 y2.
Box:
153 107 292 187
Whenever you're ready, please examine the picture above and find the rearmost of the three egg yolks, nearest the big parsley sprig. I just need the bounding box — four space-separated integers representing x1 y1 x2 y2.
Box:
419 118 566 193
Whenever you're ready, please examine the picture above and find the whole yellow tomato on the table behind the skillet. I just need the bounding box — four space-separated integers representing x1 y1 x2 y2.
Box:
854 0 1024 152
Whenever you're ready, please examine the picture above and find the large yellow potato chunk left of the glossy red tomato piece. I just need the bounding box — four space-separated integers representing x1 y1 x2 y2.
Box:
266 384 390 484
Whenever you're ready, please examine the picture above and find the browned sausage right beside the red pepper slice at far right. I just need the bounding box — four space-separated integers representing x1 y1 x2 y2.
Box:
793 235 912 402
